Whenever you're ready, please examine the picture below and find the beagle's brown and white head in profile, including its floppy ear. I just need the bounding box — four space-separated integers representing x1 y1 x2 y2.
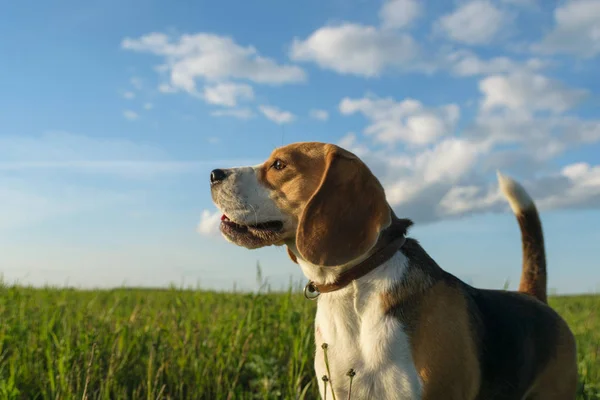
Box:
210 142 392 266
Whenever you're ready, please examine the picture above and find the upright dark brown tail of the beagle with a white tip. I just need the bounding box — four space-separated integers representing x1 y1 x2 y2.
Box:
498 172 548 303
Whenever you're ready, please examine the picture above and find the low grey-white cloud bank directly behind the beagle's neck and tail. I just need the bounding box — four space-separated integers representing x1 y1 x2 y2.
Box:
340 135 600 223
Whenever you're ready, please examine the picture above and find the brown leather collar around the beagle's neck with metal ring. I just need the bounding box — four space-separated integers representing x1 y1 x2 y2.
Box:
304 216 411 300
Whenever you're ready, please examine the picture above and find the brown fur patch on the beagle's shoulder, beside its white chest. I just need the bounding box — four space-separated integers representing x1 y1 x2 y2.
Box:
381 269 480 400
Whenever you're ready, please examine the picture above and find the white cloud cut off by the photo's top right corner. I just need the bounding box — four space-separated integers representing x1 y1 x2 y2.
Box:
533 0 600 57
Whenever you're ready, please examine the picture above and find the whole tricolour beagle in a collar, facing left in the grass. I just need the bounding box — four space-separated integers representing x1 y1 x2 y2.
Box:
210 142 577 400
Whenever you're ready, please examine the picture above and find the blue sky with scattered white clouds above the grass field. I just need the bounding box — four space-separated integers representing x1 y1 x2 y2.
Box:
0 0 600 293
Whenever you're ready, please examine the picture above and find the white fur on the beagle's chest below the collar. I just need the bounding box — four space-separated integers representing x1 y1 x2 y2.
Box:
308 253 421 400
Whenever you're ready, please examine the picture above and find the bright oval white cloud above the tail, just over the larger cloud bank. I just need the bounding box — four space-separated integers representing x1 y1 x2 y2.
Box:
479 73 587 113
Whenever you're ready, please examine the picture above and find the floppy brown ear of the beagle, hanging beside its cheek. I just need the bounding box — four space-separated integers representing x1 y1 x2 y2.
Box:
296 146 391 266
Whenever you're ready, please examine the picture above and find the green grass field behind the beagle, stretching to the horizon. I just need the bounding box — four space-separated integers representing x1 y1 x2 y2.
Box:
0 285 600 399
